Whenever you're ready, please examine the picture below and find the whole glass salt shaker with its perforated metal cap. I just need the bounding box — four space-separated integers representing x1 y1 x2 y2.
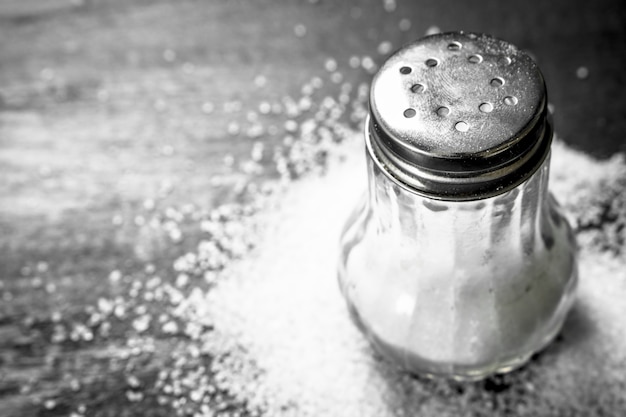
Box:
338 32 577 380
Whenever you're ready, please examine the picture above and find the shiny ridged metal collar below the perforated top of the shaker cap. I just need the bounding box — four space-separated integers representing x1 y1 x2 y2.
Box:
364 115 553 201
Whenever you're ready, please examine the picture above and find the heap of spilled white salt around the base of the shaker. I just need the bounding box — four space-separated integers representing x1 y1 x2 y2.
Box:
197 134 626 417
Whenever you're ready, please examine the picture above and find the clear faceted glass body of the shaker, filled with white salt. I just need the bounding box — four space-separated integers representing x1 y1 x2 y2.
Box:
339 141 577 380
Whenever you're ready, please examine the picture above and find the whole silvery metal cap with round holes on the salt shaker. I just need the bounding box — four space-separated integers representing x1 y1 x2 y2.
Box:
366 32 552 200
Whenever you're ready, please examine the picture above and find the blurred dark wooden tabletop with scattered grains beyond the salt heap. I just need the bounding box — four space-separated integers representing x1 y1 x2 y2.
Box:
0 0 626 416
